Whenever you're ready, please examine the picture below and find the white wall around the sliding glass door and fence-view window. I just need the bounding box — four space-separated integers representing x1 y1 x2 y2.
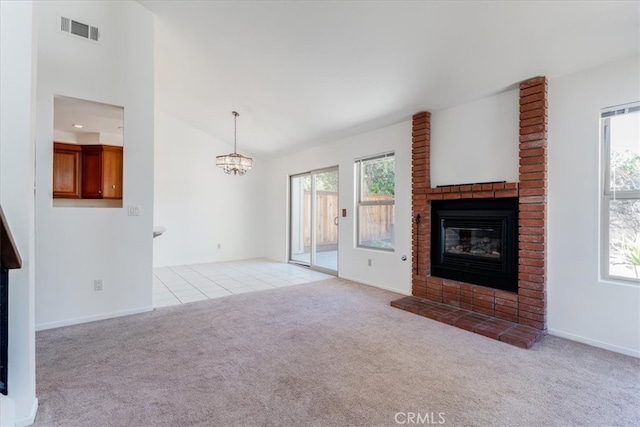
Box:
264 121 411 295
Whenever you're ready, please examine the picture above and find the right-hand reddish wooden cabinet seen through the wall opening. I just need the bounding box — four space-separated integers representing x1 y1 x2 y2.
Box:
81 145 122 199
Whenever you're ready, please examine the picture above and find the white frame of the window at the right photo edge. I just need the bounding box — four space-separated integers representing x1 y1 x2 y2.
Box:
600 102 640 285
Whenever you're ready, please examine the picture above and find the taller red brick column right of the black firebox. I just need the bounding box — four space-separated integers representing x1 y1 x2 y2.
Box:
518 77 548 330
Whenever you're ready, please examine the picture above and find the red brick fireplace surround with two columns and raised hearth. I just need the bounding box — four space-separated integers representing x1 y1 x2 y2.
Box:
391 77 548 348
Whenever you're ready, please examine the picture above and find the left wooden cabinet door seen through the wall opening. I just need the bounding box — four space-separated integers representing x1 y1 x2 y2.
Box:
53 142 82 199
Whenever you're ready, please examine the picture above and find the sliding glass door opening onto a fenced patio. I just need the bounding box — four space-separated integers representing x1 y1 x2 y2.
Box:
289 167 338 274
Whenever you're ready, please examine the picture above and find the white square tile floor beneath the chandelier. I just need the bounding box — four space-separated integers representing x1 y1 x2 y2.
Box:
153 259 334 308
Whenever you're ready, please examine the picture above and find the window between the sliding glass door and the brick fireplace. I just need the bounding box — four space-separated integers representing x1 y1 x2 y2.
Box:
355 153 396 251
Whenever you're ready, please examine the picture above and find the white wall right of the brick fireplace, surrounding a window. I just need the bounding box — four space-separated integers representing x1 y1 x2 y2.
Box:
547 58 640 357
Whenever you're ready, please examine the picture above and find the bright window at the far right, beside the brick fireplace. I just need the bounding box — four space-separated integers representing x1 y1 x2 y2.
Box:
600 103 640 283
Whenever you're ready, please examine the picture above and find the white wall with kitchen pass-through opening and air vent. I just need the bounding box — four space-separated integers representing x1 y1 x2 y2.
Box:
35 1 154 329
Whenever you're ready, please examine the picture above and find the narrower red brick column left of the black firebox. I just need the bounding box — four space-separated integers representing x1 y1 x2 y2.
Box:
411 111 431 298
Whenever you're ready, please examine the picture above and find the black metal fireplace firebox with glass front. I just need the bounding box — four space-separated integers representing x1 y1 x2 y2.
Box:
431 198 518 292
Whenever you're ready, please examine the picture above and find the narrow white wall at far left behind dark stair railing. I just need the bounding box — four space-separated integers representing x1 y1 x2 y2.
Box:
0 1 38 427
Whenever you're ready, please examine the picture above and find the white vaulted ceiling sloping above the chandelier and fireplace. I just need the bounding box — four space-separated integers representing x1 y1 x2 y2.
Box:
140 1 640 158
